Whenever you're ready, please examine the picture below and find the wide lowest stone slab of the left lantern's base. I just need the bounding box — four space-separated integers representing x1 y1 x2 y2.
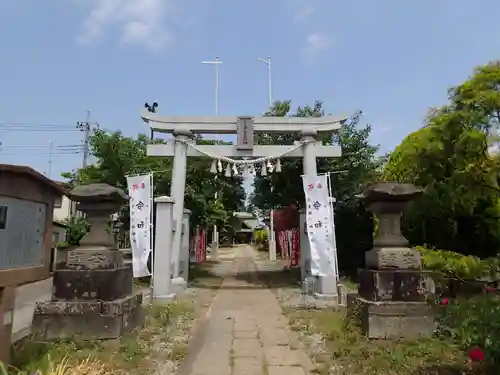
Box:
31 293 144 341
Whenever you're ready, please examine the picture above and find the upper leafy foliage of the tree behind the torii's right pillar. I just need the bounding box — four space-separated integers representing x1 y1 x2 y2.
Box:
251 101 381 211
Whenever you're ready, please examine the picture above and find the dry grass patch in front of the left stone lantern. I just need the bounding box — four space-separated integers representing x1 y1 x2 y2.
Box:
12 301 194 375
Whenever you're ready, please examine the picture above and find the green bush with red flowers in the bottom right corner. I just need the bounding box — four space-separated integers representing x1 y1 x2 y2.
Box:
436 292 500 365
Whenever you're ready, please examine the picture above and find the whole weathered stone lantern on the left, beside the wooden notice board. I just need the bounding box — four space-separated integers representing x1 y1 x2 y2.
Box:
32 184 143 340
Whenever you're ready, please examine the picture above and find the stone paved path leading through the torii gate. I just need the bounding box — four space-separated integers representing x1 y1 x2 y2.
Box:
180 246 310 375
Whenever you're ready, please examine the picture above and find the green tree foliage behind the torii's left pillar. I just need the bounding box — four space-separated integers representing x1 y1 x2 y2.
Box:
63 130 245 234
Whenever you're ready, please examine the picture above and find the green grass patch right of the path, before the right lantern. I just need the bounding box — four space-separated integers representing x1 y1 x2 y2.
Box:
285 308 470 375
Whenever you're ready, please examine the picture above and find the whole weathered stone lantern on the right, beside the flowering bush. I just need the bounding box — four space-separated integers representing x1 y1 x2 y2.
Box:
348 182 435 338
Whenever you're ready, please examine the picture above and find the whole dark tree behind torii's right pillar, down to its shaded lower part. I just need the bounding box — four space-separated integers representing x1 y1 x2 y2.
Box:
251 101 383 273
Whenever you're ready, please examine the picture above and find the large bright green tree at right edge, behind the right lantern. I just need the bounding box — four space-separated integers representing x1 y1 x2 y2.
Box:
383 62 500 256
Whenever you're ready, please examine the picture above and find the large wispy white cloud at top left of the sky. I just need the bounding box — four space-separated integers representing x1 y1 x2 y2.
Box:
78 0 172 50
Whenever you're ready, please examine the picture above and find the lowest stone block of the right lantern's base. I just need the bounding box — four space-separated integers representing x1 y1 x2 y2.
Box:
347 294 436 339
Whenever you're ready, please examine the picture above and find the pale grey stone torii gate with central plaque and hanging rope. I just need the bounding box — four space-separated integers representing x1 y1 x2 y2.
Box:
141 110 347 296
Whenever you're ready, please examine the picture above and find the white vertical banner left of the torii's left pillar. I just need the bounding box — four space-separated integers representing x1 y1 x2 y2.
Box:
127 174 153 277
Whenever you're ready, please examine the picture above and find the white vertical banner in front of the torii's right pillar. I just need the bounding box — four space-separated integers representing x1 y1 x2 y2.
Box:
302 175 336 277
